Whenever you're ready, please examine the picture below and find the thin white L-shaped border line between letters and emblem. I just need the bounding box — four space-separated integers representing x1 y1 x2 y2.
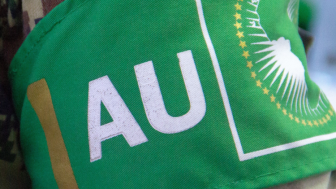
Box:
195 0 336 161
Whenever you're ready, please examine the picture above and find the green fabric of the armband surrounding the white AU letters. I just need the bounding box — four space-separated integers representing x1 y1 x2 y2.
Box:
10 0 336 188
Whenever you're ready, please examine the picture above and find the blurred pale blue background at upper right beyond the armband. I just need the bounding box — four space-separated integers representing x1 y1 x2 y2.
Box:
299 0 336 107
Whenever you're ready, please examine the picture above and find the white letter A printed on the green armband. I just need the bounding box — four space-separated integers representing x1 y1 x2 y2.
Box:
88 76 148 162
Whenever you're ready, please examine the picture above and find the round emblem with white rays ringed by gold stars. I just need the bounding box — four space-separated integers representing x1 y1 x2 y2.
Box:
234 0 334 127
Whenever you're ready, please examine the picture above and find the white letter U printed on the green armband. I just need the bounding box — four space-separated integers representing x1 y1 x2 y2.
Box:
134 50 206 134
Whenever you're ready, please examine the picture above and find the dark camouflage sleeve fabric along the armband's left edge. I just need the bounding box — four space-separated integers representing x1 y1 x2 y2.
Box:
0 0 63 189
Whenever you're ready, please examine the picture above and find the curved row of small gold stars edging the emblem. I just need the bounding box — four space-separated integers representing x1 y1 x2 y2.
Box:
233 0 335 127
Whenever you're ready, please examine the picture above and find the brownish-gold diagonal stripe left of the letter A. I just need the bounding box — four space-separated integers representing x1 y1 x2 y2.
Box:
27 79 78 189
